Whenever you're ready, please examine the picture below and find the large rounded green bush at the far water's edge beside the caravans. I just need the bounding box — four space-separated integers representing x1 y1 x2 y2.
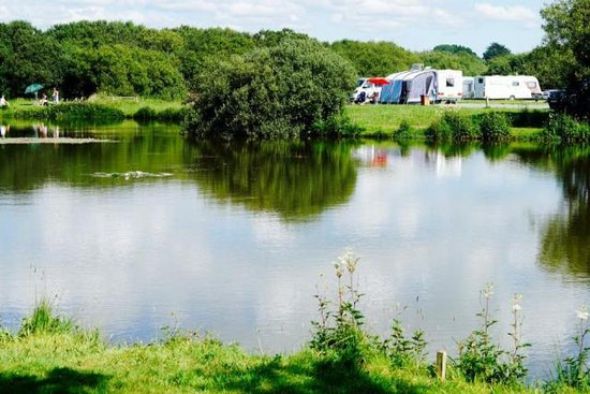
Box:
187 39 355 138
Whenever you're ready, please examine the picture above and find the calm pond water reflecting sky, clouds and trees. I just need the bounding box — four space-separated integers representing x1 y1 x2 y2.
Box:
0 123 590 376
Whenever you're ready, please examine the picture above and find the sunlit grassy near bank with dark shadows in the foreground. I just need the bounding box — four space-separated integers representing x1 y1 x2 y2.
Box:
0 304 532 393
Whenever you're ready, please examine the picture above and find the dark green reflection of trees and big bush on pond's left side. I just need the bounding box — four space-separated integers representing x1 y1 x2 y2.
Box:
0 123 358 220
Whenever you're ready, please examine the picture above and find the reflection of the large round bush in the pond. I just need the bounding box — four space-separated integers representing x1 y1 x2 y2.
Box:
185 141 358 220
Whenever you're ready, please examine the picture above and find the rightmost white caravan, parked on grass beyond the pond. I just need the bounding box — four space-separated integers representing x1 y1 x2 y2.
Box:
474 75 543 100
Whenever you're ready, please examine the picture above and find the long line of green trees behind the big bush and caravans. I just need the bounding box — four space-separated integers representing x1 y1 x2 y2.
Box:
0 17 576 99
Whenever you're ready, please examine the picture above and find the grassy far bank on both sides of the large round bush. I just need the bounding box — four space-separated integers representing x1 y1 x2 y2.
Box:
0 95 547 141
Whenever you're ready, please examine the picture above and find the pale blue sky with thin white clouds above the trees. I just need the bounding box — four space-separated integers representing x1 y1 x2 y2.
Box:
0 0 545 54
